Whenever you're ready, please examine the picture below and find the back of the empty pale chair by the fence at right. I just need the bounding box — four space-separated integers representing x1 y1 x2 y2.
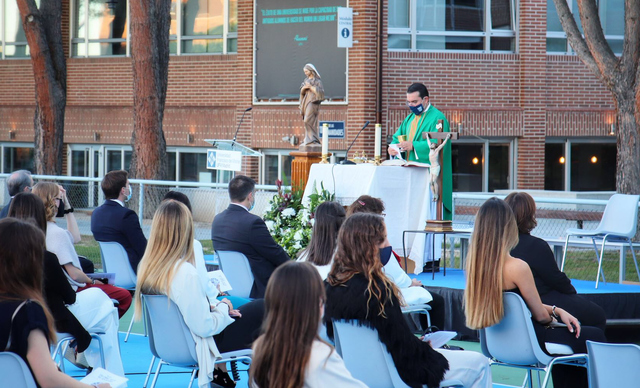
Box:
596 194 640 238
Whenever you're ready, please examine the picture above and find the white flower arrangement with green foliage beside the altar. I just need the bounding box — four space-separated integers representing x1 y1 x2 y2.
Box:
263 179 335 259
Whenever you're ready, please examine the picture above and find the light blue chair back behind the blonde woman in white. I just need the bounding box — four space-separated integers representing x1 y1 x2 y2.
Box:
141 294 198 366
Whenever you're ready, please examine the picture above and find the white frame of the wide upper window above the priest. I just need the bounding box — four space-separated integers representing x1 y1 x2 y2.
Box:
387 0 518 53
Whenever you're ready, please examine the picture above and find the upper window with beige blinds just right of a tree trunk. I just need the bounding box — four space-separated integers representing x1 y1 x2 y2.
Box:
169 0 238 55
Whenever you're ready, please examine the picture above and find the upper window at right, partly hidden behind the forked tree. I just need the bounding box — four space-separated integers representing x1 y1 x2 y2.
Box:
547 0 624 55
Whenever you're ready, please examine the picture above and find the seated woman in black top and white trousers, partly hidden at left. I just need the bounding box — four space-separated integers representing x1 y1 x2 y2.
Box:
9 193 124 376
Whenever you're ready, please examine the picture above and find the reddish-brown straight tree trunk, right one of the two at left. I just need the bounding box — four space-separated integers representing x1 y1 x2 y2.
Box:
130 0 171 179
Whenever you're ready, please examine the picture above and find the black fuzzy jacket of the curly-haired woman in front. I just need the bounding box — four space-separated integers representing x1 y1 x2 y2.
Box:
324 274 449 387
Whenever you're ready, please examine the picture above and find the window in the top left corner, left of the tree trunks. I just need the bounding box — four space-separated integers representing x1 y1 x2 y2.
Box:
0 0 33 59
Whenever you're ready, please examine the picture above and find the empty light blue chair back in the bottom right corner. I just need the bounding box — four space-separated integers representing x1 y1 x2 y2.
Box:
587 341 640 388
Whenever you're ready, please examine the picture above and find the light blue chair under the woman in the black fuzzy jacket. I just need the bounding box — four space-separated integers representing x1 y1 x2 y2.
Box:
333 320 462 388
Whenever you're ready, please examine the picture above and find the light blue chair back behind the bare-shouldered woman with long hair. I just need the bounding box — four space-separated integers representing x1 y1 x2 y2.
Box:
480 292 552 366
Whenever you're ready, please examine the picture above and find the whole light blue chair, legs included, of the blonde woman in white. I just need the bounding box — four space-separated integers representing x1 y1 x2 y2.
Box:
141 294 252 388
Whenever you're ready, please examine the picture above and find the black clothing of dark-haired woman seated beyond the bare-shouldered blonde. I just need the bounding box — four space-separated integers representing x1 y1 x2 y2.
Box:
511 233 607 330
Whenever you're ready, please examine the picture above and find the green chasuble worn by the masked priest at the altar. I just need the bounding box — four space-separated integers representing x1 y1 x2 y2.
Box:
391 105 453 220
